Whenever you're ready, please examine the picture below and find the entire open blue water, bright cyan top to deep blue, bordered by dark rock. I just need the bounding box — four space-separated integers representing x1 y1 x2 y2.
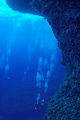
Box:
0 0 66 120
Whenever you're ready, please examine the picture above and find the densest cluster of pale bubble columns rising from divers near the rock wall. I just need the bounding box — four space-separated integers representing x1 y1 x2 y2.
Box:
35 57 54 110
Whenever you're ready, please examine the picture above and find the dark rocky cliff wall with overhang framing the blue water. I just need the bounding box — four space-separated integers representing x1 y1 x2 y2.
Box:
7 0 80 120
